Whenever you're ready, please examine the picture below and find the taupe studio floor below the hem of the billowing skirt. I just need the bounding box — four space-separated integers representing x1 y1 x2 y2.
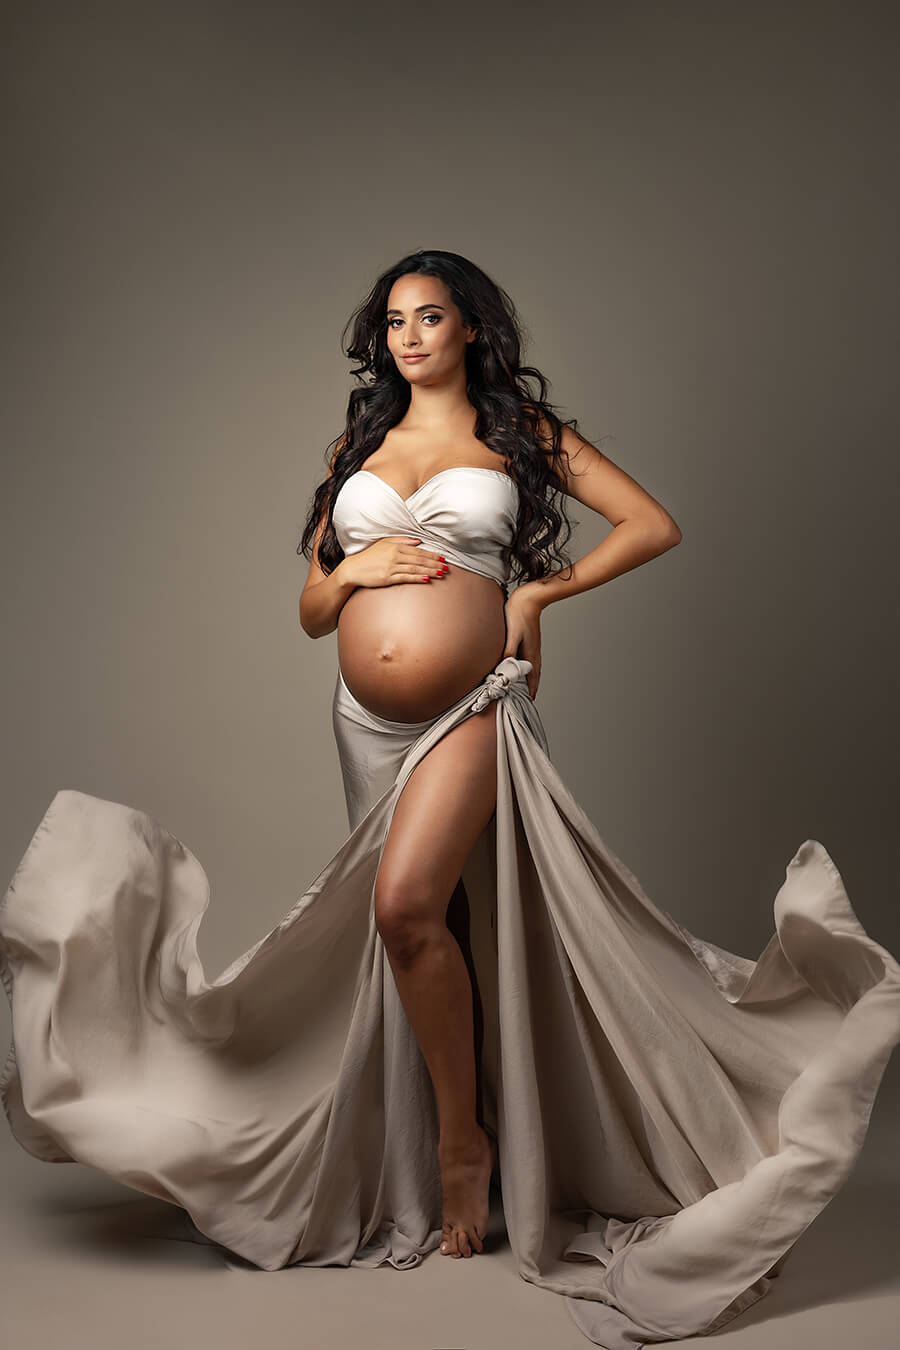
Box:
0 1056 900 1350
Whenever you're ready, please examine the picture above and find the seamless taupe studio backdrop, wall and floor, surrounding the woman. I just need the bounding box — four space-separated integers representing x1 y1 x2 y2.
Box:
0 0 900 1350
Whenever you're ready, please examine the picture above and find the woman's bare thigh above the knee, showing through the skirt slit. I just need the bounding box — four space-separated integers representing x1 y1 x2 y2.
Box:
375 702 497 919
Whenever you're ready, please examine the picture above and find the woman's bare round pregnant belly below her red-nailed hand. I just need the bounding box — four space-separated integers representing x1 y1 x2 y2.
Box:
337 563 506 722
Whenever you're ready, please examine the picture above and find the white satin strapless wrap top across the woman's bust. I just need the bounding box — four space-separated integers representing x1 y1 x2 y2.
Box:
332 464 518 586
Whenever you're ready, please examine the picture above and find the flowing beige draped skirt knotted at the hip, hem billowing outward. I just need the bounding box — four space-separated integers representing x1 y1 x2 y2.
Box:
0 657 900 1350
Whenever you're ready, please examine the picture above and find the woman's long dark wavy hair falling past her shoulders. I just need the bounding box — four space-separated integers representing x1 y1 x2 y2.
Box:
297 248 593 581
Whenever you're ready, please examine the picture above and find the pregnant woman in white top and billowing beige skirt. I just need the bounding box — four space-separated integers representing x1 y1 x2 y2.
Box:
0 251 900 1350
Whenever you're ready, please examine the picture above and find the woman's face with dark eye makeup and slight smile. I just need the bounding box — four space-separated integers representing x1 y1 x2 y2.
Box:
385 273 475 385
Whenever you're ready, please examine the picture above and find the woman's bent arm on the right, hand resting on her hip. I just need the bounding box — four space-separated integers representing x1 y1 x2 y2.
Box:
503 427 681 698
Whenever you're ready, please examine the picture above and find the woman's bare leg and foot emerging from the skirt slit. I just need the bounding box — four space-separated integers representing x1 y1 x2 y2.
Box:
375 703 497 1257
